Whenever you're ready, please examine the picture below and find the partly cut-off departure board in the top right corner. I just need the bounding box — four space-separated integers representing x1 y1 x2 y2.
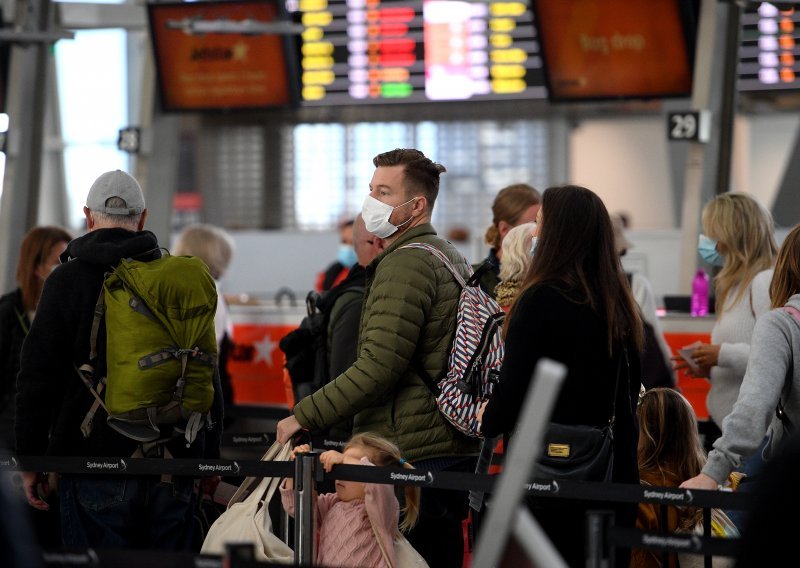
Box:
738 2 800 91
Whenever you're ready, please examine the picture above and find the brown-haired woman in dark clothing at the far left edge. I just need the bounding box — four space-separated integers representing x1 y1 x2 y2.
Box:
0 227 72 448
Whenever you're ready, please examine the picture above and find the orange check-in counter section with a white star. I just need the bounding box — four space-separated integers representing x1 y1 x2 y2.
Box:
228 298 306 407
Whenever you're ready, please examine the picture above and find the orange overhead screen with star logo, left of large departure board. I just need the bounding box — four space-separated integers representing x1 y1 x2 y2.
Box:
148 0 293 111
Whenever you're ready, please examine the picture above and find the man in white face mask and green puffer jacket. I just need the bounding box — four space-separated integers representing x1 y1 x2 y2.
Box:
278 149 479 568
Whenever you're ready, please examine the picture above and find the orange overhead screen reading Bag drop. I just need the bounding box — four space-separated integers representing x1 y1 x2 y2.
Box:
534 0 692 101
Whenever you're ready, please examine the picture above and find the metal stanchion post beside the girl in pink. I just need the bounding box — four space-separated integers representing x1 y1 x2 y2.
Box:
294 452 319 566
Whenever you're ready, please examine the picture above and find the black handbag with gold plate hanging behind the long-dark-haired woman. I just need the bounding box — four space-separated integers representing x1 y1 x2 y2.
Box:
535 349 628 481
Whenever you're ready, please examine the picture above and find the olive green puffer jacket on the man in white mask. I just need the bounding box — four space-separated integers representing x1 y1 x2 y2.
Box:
294 224 479 462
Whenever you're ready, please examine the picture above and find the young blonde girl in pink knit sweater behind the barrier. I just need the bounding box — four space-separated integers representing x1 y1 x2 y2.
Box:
281 432 419 568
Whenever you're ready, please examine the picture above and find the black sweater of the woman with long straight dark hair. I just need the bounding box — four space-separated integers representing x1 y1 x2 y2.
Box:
482 286 641 483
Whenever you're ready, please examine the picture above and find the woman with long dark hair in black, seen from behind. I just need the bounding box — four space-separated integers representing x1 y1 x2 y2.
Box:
482 185 643 566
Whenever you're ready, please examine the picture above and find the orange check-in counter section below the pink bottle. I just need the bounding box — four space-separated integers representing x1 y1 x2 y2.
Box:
659 312 716 420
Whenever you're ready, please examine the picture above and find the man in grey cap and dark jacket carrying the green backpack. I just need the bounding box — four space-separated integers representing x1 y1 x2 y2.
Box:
16 170 222 549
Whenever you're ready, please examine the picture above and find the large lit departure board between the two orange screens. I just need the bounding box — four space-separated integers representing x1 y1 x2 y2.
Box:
297 0 547 106
